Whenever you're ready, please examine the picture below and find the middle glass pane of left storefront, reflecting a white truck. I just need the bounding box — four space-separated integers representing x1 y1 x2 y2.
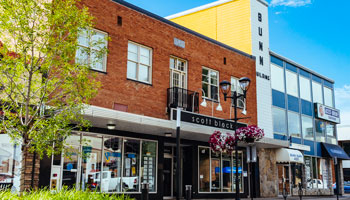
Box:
102 137 122 192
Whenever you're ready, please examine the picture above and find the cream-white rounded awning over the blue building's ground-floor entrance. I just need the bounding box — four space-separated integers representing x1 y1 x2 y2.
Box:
276 148 304 163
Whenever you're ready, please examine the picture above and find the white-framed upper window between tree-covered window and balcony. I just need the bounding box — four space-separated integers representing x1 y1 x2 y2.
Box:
127 42 152 83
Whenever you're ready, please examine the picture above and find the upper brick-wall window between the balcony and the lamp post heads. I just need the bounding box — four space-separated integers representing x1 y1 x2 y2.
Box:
202 67 219 101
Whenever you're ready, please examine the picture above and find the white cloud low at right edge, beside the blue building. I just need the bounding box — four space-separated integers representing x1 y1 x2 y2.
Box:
334 85 350 140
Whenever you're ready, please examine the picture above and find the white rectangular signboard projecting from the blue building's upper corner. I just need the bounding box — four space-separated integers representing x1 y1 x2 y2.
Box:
315 103 340 124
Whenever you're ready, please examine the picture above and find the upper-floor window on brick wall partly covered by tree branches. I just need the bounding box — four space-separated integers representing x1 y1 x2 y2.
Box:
76 30 107 72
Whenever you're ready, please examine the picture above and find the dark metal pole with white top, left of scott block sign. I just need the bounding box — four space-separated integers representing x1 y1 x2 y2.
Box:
176 108 181 200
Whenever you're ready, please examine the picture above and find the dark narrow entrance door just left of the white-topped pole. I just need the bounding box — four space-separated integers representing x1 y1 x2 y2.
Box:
163 153 173 199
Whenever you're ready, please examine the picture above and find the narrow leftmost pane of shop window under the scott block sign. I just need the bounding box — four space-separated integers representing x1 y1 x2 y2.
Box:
198 147 210 192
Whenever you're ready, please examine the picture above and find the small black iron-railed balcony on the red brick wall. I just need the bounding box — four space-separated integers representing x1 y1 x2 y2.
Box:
167 87 199 112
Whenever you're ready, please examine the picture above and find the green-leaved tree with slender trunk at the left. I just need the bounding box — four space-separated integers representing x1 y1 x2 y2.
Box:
0 0 106 191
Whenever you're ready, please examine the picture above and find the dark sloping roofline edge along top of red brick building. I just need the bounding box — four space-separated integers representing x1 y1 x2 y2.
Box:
112 0 256 60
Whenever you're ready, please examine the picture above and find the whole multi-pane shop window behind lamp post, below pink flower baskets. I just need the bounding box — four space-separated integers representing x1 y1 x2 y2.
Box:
198 147 244 193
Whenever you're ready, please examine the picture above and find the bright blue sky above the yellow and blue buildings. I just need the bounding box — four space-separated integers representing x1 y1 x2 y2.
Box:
127 0 350 133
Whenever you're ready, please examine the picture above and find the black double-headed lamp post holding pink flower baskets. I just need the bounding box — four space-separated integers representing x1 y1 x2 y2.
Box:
220 77 250 200
